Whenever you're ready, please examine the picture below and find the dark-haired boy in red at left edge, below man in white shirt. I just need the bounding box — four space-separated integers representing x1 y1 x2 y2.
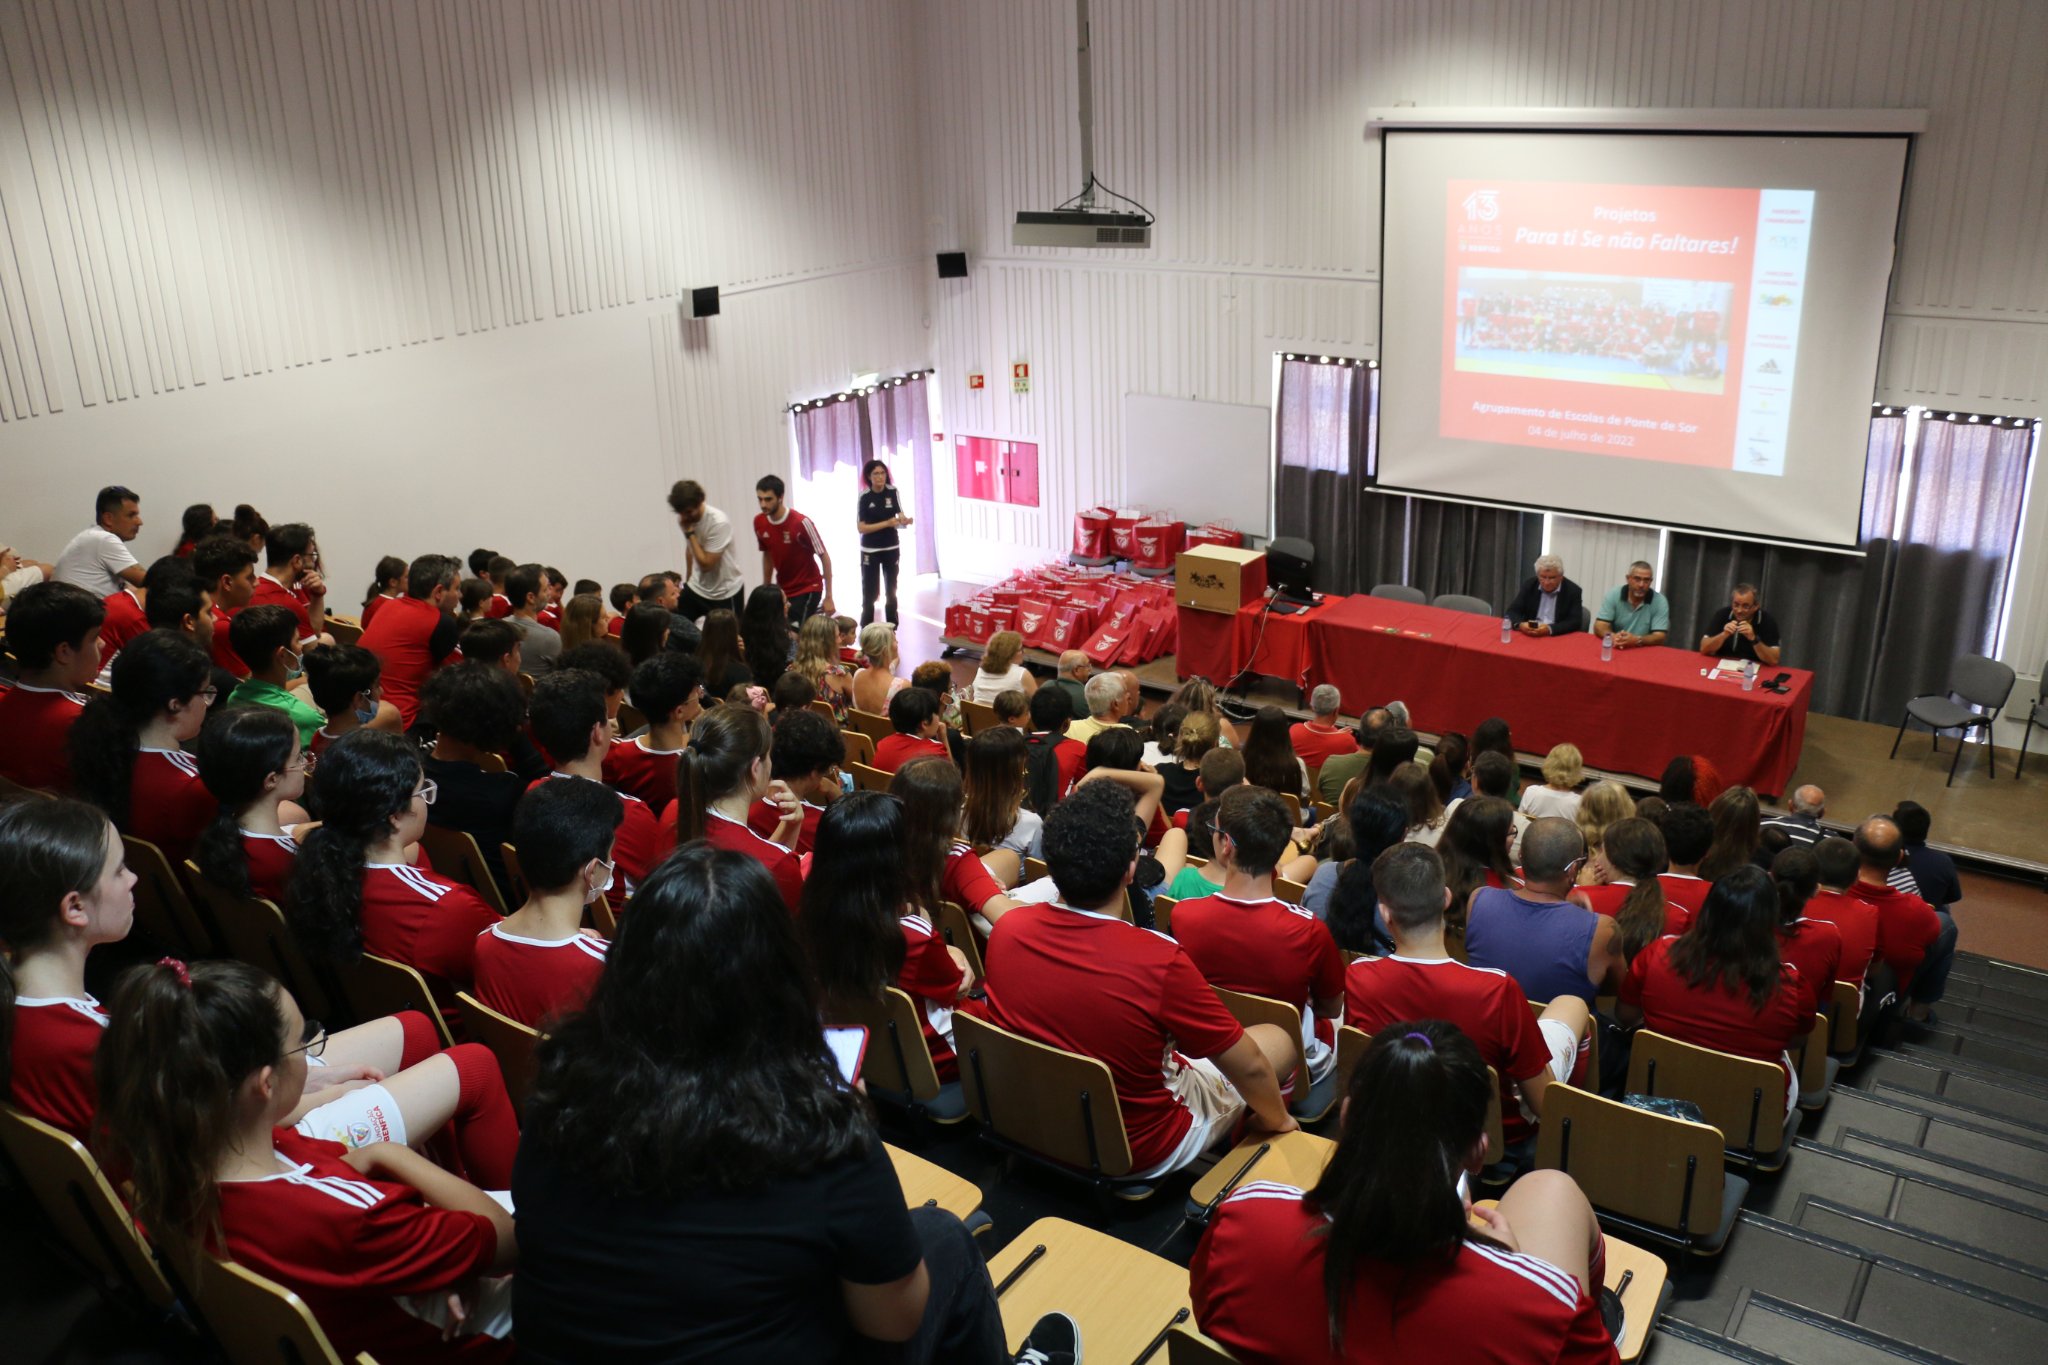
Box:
0 581 106 792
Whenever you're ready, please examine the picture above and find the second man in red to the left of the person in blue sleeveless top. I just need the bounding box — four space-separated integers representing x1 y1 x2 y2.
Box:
1174 786 1343 1093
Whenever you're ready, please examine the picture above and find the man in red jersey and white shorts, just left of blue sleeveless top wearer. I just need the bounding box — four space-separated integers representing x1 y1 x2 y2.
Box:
1351 843 1591 1162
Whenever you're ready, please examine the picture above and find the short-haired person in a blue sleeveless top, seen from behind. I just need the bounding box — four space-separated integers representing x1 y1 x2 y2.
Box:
1464 817 1628 1005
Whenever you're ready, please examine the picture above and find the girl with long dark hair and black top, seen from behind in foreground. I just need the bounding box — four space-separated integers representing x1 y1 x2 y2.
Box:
512 847 1048 1365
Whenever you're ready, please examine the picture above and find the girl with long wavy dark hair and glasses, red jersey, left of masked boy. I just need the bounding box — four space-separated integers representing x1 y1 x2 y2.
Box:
285 731 498 1011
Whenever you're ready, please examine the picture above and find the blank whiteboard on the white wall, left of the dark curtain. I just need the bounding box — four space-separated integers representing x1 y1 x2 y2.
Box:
1124 393 1274 540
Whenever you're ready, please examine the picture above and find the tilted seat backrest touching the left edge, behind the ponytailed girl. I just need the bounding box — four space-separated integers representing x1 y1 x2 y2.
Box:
0 1105 174 1308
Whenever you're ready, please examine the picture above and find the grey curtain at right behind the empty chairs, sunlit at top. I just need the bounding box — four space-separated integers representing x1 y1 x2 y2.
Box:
1663 415 2032 722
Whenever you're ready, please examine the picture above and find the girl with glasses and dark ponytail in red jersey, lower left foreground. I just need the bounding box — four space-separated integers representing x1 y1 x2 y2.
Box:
96 958 518 1361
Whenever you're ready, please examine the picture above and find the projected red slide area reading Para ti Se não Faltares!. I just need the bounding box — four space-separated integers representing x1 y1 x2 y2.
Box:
1442 180 1765 469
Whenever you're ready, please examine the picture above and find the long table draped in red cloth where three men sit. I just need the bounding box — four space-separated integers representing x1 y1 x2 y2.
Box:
1180 598 1812 796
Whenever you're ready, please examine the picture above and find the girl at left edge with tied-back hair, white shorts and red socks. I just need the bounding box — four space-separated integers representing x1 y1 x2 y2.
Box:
0 794 518 1189
